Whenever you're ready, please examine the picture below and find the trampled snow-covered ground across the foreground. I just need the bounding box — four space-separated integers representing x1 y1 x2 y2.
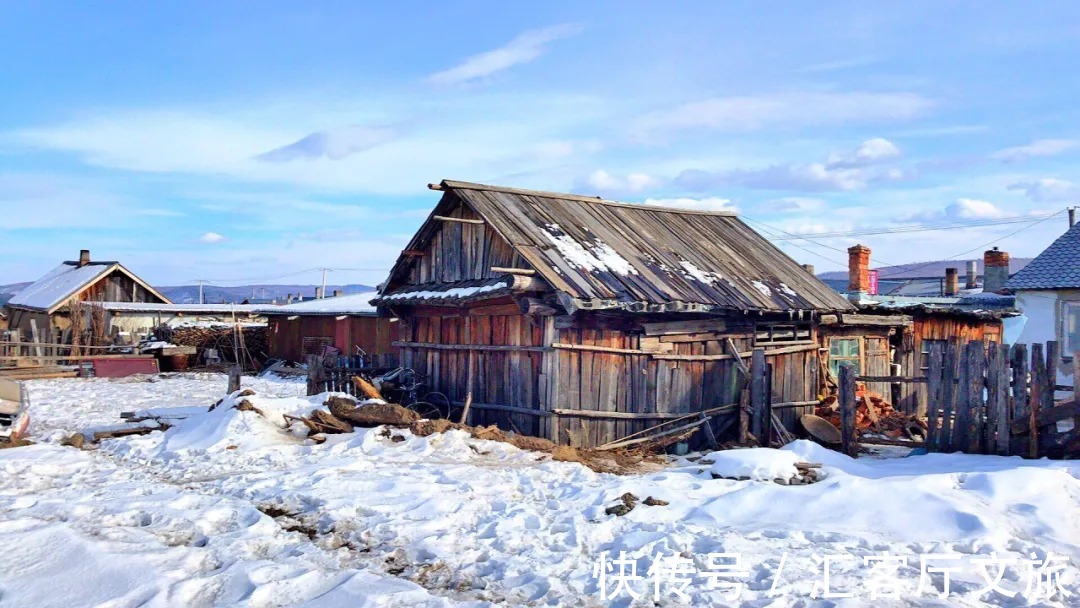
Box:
0 374 1080 607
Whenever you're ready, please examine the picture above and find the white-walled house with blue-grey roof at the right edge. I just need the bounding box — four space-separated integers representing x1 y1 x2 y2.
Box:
1005 225 1080 384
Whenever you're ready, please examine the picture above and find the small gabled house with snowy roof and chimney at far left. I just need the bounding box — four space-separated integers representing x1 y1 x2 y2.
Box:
5 249 171 342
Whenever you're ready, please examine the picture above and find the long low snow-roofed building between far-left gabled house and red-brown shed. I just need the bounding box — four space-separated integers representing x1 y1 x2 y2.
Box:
94 302 266 337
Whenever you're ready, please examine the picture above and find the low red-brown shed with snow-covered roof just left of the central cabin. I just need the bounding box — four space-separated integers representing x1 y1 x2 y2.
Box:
255 292 397 363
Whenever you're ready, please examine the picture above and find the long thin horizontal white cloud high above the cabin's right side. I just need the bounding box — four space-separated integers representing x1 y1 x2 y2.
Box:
632 92 933 139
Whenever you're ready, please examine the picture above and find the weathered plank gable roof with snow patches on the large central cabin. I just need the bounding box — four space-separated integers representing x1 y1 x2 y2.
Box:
379 180 853 312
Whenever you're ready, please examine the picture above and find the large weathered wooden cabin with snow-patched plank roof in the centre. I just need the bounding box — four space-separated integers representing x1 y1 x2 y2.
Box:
373 181 855 445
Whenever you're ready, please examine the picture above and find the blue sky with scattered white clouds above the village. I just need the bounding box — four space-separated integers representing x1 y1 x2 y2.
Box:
0 1 1080 284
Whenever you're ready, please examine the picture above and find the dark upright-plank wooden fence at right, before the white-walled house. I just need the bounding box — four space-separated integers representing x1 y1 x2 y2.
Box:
839 340 1080 458
